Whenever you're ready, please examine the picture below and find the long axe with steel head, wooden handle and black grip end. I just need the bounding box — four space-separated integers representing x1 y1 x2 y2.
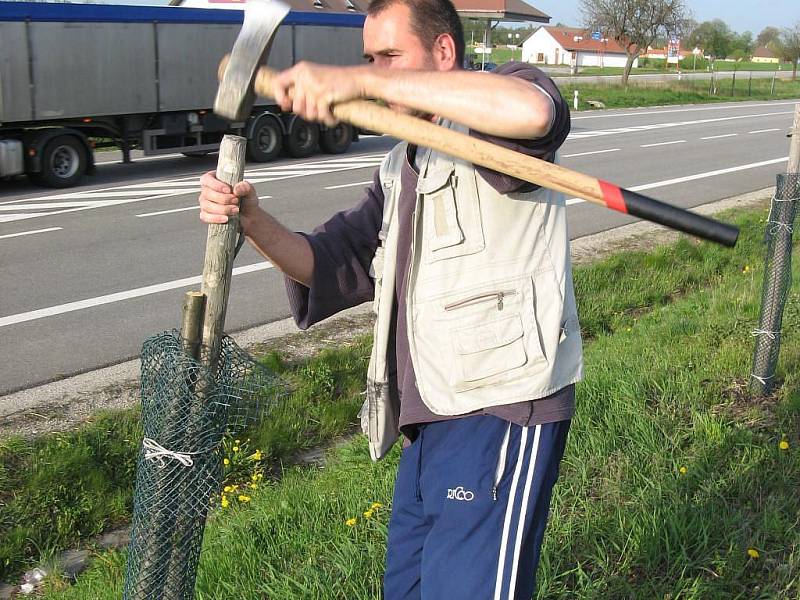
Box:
214 0 739 246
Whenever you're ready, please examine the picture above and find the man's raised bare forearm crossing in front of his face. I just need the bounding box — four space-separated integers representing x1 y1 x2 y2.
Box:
362 68 553 139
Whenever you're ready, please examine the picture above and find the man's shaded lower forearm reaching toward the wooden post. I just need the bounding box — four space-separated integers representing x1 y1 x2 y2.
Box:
242 208 314 287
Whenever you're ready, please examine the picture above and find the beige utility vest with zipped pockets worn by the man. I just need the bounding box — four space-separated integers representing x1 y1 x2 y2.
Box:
360 121 583 460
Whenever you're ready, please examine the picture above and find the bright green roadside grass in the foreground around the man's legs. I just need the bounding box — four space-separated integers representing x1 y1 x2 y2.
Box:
32 205 800 600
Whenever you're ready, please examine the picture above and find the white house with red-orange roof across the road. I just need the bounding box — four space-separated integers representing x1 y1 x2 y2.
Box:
522 27 639 67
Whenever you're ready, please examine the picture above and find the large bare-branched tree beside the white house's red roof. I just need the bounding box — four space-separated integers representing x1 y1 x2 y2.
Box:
580 0 688 86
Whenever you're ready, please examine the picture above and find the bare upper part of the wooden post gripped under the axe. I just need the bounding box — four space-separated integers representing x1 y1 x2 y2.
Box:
202 135 247 370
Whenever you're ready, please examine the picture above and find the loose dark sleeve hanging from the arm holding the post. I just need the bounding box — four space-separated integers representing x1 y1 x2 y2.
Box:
284 171 383 329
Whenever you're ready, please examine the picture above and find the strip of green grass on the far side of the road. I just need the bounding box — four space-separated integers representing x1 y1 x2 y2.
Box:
555 77 800 110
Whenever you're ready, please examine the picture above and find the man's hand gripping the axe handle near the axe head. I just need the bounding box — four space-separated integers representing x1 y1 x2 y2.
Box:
272 62 369 127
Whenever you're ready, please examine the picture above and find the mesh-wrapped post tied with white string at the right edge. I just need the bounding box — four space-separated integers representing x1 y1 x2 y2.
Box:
750 173 800 396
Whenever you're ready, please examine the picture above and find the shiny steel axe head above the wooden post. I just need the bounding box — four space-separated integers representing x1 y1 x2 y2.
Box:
214 0 289 122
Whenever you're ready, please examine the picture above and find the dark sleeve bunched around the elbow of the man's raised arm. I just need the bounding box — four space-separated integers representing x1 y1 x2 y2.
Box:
470 62 570 194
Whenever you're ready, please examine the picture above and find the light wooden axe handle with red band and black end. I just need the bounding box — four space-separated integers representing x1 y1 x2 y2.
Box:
248 67 739 246
